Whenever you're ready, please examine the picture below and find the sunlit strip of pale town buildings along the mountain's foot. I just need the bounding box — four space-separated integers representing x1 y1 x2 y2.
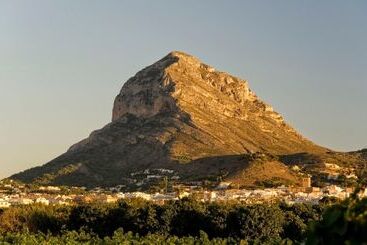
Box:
0 178 367 208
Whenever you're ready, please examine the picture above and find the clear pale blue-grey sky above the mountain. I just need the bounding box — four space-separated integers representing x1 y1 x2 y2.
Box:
0 0 367 177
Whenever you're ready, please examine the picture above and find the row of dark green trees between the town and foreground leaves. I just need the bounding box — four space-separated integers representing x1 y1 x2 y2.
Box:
0 198 336 244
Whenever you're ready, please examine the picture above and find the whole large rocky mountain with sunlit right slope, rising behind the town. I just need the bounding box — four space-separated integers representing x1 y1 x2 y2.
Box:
11 51 364 187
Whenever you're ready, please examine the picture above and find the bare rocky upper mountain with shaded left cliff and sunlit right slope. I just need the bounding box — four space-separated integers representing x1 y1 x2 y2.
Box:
109 52 320 157
